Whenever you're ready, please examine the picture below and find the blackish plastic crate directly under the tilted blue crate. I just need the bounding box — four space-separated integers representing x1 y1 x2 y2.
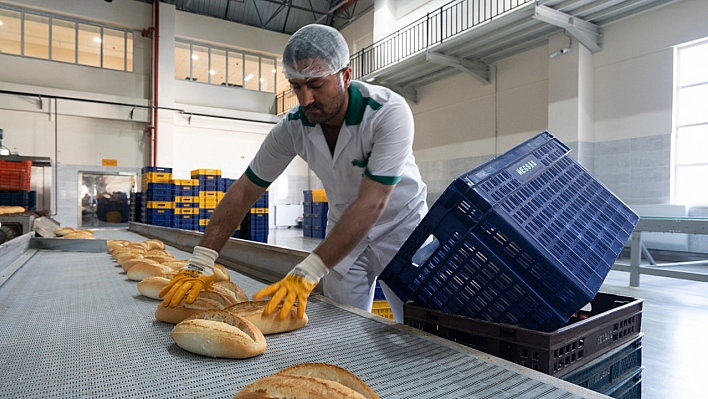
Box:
403 292 644 376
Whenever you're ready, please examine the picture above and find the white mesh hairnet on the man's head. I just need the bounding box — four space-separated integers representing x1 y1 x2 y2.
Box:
283 24 349 79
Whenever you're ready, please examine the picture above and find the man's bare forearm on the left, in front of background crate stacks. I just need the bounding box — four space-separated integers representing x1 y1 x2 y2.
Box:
199 174 265 252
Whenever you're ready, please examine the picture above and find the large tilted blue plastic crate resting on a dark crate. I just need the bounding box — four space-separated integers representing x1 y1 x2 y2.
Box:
380 132 639 331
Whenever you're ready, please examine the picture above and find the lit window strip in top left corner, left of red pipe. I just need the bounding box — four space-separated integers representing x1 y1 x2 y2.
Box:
0 6 133 72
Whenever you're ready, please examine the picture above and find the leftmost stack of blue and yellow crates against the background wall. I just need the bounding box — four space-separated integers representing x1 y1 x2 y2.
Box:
140 166 175 227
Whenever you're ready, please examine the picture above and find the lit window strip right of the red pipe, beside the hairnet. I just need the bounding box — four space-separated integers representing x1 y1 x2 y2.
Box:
175 41 284 93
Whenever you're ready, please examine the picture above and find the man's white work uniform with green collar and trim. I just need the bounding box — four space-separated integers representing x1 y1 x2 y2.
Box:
246 81 427 321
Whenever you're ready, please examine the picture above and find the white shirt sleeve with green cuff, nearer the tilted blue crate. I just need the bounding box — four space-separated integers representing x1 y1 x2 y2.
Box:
364 98 414 185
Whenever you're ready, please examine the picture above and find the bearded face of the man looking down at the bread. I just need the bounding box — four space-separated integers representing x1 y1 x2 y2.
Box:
289 61 351 124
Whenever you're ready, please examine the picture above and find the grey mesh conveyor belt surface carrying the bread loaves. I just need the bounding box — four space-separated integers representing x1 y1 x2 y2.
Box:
0 233 598 399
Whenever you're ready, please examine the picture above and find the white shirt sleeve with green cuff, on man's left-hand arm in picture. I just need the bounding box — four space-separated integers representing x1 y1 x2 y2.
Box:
245 119 297 187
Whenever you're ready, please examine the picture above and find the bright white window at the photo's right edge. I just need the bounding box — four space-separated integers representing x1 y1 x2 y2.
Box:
673 41 708 205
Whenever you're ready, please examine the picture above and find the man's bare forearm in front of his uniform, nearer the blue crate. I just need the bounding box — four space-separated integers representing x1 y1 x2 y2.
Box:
313 177 396 269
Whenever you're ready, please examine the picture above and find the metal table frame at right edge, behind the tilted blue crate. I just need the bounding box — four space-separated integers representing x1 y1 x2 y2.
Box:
612 217 708 287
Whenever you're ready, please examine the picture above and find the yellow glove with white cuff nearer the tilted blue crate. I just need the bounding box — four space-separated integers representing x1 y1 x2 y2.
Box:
253 253 329 320
